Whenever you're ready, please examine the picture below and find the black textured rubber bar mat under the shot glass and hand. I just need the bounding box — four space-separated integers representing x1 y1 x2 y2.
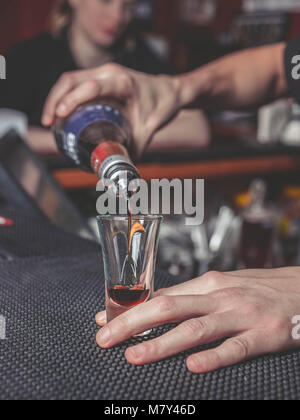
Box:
0 207 300 400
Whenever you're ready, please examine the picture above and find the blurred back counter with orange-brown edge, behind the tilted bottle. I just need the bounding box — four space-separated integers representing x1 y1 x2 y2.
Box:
47 120 300 189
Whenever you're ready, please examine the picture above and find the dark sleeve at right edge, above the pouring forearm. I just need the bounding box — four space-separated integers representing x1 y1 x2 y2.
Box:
284 35 300 104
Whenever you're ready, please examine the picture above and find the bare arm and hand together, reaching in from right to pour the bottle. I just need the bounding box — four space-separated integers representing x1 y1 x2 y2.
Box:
43 43 288 155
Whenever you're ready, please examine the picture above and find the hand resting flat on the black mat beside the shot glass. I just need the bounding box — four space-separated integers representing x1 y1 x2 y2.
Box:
96 268 300 373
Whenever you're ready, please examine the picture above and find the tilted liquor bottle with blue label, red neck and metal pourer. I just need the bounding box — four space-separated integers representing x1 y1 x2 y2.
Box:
53 99 140 201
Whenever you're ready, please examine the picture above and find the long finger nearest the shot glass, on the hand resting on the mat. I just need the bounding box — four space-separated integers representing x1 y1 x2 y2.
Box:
97 296 218 348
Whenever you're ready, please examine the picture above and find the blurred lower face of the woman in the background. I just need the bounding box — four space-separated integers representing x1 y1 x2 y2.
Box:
70 0 137 48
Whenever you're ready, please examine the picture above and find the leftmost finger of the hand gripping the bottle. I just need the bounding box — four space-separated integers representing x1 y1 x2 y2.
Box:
42 70 91 126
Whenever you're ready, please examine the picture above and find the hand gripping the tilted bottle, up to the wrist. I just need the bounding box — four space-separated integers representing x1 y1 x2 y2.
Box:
43 64 183 155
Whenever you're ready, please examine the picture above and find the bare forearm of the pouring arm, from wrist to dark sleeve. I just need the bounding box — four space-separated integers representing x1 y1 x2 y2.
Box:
179 44 287 110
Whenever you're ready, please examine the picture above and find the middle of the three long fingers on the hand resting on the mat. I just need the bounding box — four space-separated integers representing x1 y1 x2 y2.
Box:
125 312 239 365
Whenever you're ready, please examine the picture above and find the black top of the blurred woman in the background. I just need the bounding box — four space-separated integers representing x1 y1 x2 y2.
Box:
0 28 169 126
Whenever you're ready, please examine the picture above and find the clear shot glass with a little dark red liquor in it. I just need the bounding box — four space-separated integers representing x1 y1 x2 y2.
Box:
97 216 162 322
